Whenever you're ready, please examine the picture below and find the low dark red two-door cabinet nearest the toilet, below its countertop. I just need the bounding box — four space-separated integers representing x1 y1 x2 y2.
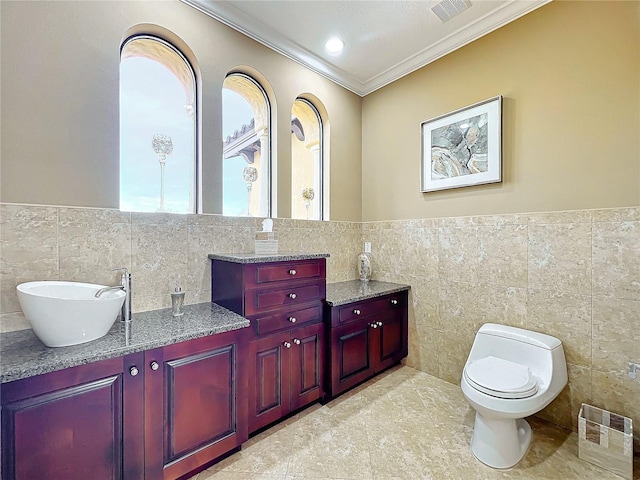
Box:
326 291 409 397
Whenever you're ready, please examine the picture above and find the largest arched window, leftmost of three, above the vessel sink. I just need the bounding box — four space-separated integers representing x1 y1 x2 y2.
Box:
120 35 196 213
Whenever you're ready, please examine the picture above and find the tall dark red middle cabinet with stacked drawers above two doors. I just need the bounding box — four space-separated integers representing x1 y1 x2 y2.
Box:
211 258 326 433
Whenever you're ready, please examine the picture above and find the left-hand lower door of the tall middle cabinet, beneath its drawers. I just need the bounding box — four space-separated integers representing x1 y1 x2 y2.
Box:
249 332 292 432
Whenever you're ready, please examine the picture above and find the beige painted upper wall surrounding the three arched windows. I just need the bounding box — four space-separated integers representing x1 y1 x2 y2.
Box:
0 0 362 221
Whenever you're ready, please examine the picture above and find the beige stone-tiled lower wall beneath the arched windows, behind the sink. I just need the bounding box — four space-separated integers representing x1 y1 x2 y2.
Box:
0 204 361 331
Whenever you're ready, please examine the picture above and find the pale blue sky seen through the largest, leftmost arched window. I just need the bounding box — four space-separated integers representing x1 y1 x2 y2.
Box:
120 56 195 213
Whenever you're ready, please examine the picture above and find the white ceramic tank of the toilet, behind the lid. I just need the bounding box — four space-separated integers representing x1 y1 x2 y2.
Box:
467 323 567 388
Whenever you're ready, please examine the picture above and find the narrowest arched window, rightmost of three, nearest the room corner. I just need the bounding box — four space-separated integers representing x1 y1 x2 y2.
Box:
291 98 323 220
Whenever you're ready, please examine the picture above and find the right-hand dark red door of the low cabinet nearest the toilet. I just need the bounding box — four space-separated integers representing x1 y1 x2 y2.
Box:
372 310 408 372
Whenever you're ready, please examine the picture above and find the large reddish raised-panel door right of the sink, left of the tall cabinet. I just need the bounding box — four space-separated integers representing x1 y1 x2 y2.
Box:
145 332 248 479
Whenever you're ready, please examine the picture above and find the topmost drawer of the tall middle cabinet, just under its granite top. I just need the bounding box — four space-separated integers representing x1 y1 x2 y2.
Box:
246 260 326 288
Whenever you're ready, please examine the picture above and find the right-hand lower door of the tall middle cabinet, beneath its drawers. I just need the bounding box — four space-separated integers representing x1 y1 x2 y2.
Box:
291 323 325 410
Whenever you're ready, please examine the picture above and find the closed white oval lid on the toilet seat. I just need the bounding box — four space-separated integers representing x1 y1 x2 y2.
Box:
464 356 538 398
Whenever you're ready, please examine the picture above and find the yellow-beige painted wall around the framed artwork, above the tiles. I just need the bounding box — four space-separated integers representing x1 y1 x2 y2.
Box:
362 1 640 221
